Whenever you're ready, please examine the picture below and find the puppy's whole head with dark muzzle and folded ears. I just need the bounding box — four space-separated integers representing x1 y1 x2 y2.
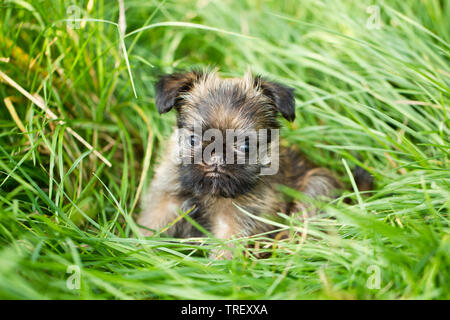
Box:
155 72 295 197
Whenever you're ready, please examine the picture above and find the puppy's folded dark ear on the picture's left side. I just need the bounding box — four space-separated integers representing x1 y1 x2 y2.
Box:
155 71 202 114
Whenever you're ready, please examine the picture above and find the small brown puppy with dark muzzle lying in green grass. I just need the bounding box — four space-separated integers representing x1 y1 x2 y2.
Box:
138 72 341 255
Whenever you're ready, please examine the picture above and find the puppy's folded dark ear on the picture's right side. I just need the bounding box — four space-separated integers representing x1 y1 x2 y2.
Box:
255 76 295 121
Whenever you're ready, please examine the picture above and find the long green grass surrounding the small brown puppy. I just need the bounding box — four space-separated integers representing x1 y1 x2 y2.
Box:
0 0 450 299
